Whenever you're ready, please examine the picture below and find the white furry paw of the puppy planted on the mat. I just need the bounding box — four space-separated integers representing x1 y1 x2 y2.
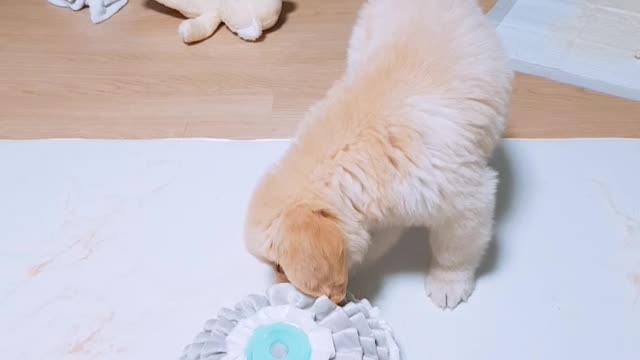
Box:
424 269 475 309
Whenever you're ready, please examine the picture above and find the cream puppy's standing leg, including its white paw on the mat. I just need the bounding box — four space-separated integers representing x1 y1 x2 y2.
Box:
425 168 497 309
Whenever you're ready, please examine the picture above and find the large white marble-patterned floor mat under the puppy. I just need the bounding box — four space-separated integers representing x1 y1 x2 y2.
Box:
0 140 640 360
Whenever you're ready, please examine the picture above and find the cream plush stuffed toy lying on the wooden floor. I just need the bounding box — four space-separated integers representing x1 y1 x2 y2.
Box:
156 0 282 43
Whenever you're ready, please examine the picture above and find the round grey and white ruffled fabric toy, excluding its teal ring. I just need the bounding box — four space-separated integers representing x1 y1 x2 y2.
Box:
180 284 401 360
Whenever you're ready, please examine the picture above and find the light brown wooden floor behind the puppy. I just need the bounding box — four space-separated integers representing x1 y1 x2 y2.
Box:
0 0 640 139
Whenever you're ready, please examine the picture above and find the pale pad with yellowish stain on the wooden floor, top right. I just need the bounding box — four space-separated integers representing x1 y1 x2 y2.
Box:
489 0 640 100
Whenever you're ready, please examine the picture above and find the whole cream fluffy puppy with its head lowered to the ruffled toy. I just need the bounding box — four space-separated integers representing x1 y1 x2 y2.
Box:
245 0 513 308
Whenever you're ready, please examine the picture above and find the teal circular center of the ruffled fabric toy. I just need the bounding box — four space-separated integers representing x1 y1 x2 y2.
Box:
245 323 311 360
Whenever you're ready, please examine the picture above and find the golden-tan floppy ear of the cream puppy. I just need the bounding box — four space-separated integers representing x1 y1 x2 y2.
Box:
278 206 348 303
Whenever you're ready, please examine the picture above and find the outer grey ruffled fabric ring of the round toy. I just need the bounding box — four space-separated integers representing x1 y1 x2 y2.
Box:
180 284 400 360
